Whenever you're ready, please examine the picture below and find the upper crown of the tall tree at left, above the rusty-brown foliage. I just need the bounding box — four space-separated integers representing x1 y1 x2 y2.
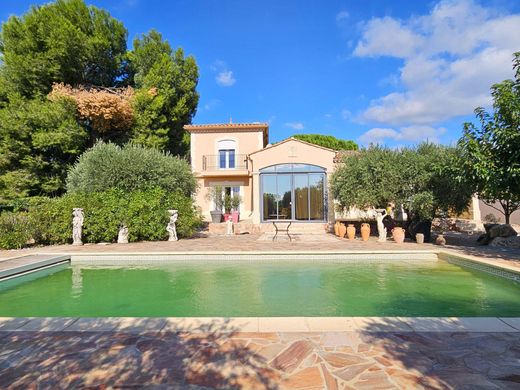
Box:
0 0 127 97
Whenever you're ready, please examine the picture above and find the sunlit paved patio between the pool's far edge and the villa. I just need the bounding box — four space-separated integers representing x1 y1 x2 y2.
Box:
0 234 520 270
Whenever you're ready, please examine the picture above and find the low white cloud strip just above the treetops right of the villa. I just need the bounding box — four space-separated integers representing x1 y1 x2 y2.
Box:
358 126 446 144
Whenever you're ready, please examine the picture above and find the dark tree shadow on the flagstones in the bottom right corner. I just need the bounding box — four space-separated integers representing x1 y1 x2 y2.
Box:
360 319 520 389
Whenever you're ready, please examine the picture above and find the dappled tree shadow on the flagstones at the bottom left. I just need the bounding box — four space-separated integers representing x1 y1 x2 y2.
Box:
0 320 279 389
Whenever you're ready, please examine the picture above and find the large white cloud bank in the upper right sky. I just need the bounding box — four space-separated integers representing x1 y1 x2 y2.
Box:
354 0 520 126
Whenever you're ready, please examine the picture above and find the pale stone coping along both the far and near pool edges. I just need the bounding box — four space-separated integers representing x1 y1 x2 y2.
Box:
0 248 520 333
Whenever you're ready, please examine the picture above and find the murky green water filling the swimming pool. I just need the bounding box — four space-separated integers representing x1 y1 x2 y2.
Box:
0 260 520 317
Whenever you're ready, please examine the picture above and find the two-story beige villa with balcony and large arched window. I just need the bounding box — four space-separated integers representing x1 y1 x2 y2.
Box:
184 123 336 229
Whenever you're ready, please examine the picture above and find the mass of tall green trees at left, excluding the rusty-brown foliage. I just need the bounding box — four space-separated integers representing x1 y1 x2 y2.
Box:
0 0 198 207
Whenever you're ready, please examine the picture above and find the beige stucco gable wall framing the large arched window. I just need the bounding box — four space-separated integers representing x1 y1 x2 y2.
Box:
250 139 336 224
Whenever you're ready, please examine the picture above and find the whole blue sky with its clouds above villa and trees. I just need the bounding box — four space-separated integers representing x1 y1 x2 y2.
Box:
0 0 520 146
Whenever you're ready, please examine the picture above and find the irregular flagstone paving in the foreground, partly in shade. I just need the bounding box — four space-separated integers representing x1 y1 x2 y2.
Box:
0 324 520 389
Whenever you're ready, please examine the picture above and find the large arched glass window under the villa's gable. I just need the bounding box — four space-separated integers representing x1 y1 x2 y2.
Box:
260 164 327 222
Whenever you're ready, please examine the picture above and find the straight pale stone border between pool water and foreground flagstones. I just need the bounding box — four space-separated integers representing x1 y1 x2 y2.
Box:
0 317 520 333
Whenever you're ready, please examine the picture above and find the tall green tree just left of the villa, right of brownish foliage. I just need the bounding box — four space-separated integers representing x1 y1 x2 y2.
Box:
129 30 199 155
